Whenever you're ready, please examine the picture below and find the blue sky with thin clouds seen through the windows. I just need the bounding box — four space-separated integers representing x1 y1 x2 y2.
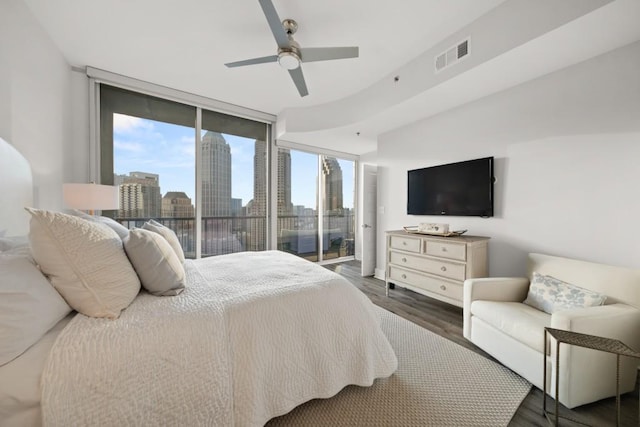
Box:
113 114 353 208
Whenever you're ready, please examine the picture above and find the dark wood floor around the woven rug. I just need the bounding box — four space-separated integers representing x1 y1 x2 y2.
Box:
324 261 640 427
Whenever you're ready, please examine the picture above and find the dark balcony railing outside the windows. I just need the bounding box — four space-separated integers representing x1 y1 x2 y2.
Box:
116 213 355 261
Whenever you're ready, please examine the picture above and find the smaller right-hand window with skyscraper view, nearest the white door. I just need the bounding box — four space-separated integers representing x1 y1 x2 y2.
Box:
277 148 355 261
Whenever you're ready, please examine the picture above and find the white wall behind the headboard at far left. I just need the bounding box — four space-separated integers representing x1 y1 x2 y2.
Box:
0 0 71 209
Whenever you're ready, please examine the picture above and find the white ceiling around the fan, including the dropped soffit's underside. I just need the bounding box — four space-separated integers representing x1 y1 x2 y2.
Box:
24 0 640 154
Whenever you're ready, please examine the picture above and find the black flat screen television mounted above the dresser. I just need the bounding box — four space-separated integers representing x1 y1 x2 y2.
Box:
407 157 494 217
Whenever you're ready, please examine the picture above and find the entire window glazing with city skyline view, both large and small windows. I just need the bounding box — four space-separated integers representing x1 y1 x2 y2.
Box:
100 85 355 261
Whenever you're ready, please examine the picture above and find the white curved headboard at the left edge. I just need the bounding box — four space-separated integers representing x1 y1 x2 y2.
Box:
0 138 33 237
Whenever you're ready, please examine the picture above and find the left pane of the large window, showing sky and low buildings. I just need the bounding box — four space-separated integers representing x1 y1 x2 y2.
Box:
113 114 196 258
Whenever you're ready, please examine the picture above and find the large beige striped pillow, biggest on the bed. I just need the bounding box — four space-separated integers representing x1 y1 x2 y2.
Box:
26 208 140 319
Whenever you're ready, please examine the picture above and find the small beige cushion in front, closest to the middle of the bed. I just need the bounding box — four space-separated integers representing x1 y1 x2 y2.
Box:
124 229 185 296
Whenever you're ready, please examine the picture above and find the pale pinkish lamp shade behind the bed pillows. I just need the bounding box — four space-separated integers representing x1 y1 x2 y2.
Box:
62 184 120 210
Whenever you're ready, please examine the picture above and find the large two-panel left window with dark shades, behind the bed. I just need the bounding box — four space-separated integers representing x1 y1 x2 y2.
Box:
100 84 269 258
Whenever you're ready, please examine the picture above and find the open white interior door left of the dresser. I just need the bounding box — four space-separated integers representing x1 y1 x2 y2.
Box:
361 165 378 276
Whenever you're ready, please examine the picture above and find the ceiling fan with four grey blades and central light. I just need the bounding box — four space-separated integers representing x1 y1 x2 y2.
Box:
224 0 358 96
